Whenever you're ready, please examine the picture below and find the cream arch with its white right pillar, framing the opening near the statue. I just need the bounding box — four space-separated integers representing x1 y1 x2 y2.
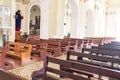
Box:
28 0 50 39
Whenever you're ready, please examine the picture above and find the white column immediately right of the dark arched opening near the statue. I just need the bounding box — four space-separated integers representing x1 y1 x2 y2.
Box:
40 0 49 39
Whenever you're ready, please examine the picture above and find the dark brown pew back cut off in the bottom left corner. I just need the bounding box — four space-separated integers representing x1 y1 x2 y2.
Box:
0 69 27 80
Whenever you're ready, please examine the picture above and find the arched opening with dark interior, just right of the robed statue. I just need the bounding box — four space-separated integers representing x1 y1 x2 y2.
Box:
29 5 41 36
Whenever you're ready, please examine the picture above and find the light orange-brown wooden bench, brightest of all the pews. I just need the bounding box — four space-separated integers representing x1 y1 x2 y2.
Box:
6 42 32 65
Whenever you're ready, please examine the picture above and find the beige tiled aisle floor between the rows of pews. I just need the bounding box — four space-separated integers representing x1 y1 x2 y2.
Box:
9 55 66 80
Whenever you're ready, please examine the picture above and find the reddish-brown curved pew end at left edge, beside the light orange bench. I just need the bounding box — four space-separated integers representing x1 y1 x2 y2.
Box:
0 47 13 70
